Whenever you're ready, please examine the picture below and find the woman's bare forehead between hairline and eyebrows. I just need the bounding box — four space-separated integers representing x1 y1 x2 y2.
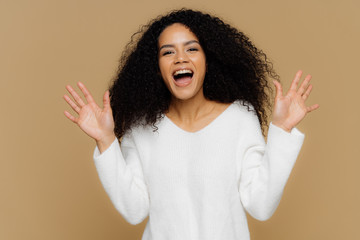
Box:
158 23 199 47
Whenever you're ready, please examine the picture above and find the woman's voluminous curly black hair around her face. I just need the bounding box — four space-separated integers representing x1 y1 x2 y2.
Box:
109 8 279 138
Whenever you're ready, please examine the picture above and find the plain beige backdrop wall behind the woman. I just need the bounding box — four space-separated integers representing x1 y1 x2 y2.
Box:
0 0 360 240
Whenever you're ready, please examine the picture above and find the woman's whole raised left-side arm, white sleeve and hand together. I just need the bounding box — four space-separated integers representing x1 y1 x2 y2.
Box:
64 82 149 224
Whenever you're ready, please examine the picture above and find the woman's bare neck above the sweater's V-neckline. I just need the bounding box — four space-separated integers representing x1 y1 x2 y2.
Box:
168 90 215 123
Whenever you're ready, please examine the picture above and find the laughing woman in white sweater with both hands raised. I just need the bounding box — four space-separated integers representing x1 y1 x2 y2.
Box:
64 9 319 240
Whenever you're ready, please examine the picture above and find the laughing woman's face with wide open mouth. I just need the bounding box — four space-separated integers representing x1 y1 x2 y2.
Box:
158 23 206 100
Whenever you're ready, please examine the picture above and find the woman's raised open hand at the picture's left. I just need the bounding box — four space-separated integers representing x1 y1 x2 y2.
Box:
64 82 115 152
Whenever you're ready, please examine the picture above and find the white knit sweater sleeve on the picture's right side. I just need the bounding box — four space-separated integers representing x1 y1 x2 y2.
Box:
238 120 304 221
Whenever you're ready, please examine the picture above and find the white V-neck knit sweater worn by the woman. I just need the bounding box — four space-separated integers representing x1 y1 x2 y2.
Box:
94 101 304 240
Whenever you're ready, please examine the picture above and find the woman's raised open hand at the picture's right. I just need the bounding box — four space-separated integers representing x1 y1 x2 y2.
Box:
272 70 319 132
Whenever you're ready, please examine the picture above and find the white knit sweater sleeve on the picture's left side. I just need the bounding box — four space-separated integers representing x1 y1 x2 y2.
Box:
94 133 149 225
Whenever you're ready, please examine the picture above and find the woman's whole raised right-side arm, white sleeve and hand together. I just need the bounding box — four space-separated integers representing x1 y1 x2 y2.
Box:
239 71 319 220
